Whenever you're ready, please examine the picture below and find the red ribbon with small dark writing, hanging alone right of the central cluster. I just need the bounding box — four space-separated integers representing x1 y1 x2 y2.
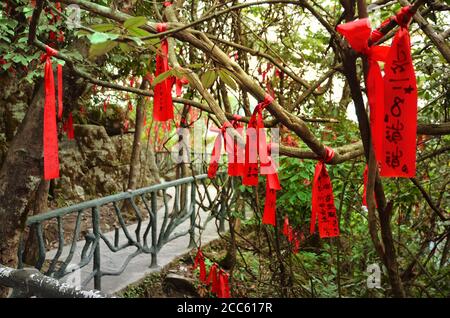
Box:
310 147 339 238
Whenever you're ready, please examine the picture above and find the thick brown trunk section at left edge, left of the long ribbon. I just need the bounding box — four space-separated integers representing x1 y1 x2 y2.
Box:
0 82 44 297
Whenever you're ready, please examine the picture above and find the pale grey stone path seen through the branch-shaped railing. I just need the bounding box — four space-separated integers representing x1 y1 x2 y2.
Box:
46 187 225 294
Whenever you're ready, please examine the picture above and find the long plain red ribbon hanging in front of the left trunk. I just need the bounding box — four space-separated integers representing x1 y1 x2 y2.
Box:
42 46 62 180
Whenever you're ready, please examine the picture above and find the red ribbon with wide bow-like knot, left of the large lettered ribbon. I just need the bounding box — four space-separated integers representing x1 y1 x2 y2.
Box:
337 18 389 161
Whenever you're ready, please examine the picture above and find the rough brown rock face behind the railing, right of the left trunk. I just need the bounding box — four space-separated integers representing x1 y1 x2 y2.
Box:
53 125 159 206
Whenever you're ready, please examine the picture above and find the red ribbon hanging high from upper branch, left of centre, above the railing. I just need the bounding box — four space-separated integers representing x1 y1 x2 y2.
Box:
153 23 174 121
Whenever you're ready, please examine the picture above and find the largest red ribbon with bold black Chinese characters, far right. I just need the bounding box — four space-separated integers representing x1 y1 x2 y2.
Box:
380 7 417 178
